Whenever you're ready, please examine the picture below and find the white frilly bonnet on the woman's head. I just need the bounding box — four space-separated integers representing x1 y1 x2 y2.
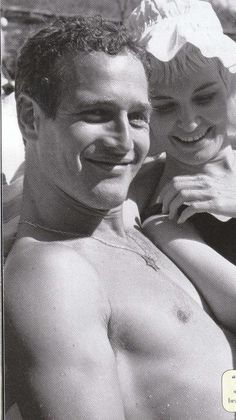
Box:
127 0 236 73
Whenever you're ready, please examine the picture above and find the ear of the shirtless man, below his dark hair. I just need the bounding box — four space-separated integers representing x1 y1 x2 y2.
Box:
16 93 43 141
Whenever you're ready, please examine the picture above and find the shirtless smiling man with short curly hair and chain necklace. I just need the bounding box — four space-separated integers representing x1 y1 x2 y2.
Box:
5 14 233 420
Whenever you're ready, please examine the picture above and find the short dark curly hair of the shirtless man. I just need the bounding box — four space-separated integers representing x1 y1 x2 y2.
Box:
15 16 148 118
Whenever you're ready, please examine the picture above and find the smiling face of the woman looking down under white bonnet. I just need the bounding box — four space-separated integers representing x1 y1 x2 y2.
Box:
151 62 227 165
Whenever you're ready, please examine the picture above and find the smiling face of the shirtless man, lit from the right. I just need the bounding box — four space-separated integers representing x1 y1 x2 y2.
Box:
38 52 150 209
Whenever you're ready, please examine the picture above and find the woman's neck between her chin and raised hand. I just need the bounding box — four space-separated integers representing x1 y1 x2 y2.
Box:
161 146 235 188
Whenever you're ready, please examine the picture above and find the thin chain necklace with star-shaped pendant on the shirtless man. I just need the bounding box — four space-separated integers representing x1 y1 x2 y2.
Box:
19 220 160 271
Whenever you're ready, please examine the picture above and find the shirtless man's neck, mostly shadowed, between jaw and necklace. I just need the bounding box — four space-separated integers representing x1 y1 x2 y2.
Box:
21 167 125 237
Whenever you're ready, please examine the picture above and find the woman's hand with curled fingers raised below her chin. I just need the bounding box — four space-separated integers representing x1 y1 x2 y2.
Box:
158 173 236 223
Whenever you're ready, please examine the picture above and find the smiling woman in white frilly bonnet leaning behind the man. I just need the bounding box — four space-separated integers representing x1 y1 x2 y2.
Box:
126 0 236 330
